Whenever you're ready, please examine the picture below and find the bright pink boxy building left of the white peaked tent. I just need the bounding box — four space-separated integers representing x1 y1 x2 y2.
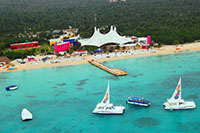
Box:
54 42 70 54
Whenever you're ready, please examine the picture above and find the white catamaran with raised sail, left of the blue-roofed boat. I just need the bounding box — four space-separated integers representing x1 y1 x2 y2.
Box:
92 82 125 115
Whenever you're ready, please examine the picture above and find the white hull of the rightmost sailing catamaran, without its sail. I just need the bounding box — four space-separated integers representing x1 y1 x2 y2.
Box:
163 101 196 110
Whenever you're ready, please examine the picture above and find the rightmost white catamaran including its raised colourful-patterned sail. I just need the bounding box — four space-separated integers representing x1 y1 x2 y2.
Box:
163 78 196 110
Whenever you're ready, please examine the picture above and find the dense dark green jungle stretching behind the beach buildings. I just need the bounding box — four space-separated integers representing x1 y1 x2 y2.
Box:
0 0 200 49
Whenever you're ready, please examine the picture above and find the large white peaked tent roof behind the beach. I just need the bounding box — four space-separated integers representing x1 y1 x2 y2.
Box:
79 26 132 47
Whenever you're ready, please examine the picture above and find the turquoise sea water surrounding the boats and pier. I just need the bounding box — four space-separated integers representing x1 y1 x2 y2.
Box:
0 52 200 133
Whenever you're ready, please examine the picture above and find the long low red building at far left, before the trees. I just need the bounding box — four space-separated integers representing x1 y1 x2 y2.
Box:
10 42 39 50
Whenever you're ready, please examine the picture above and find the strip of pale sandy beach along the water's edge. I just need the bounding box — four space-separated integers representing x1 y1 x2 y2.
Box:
0 42 200 73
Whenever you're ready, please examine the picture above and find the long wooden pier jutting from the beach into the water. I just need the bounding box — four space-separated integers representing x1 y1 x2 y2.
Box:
88 60 128 76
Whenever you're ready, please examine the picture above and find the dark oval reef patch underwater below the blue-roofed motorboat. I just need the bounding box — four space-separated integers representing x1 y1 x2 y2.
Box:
133 117 160 127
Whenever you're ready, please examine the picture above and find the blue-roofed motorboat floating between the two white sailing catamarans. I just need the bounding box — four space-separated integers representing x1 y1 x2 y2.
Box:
126 96 151 107
